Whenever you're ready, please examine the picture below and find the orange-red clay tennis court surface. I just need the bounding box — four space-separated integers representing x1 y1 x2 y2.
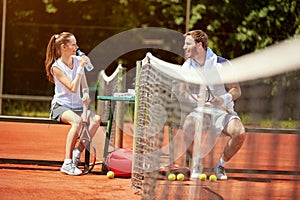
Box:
0 122 300 200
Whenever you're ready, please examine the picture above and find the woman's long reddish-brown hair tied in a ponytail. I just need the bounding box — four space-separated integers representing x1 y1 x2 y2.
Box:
45 32 74 83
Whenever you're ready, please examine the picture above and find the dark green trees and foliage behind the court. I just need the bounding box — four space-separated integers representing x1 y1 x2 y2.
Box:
0 0 300 122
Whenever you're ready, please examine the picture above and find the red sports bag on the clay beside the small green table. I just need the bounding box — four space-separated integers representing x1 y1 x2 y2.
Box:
105 148 132 178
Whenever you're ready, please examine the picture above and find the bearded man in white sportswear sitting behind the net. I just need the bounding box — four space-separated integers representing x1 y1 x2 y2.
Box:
182 30 245 180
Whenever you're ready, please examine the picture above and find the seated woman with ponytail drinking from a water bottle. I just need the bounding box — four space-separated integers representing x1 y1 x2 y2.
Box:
45 32 101 175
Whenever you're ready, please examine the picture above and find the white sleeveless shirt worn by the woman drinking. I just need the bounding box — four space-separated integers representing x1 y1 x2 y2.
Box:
51 56 83 109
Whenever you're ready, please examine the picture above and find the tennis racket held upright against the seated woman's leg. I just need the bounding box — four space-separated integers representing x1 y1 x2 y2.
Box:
78 105 96 174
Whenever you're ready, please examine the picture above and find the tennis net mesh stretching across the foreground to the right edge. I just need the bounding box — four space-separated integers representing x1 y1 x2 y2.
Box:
132 54 300 199
